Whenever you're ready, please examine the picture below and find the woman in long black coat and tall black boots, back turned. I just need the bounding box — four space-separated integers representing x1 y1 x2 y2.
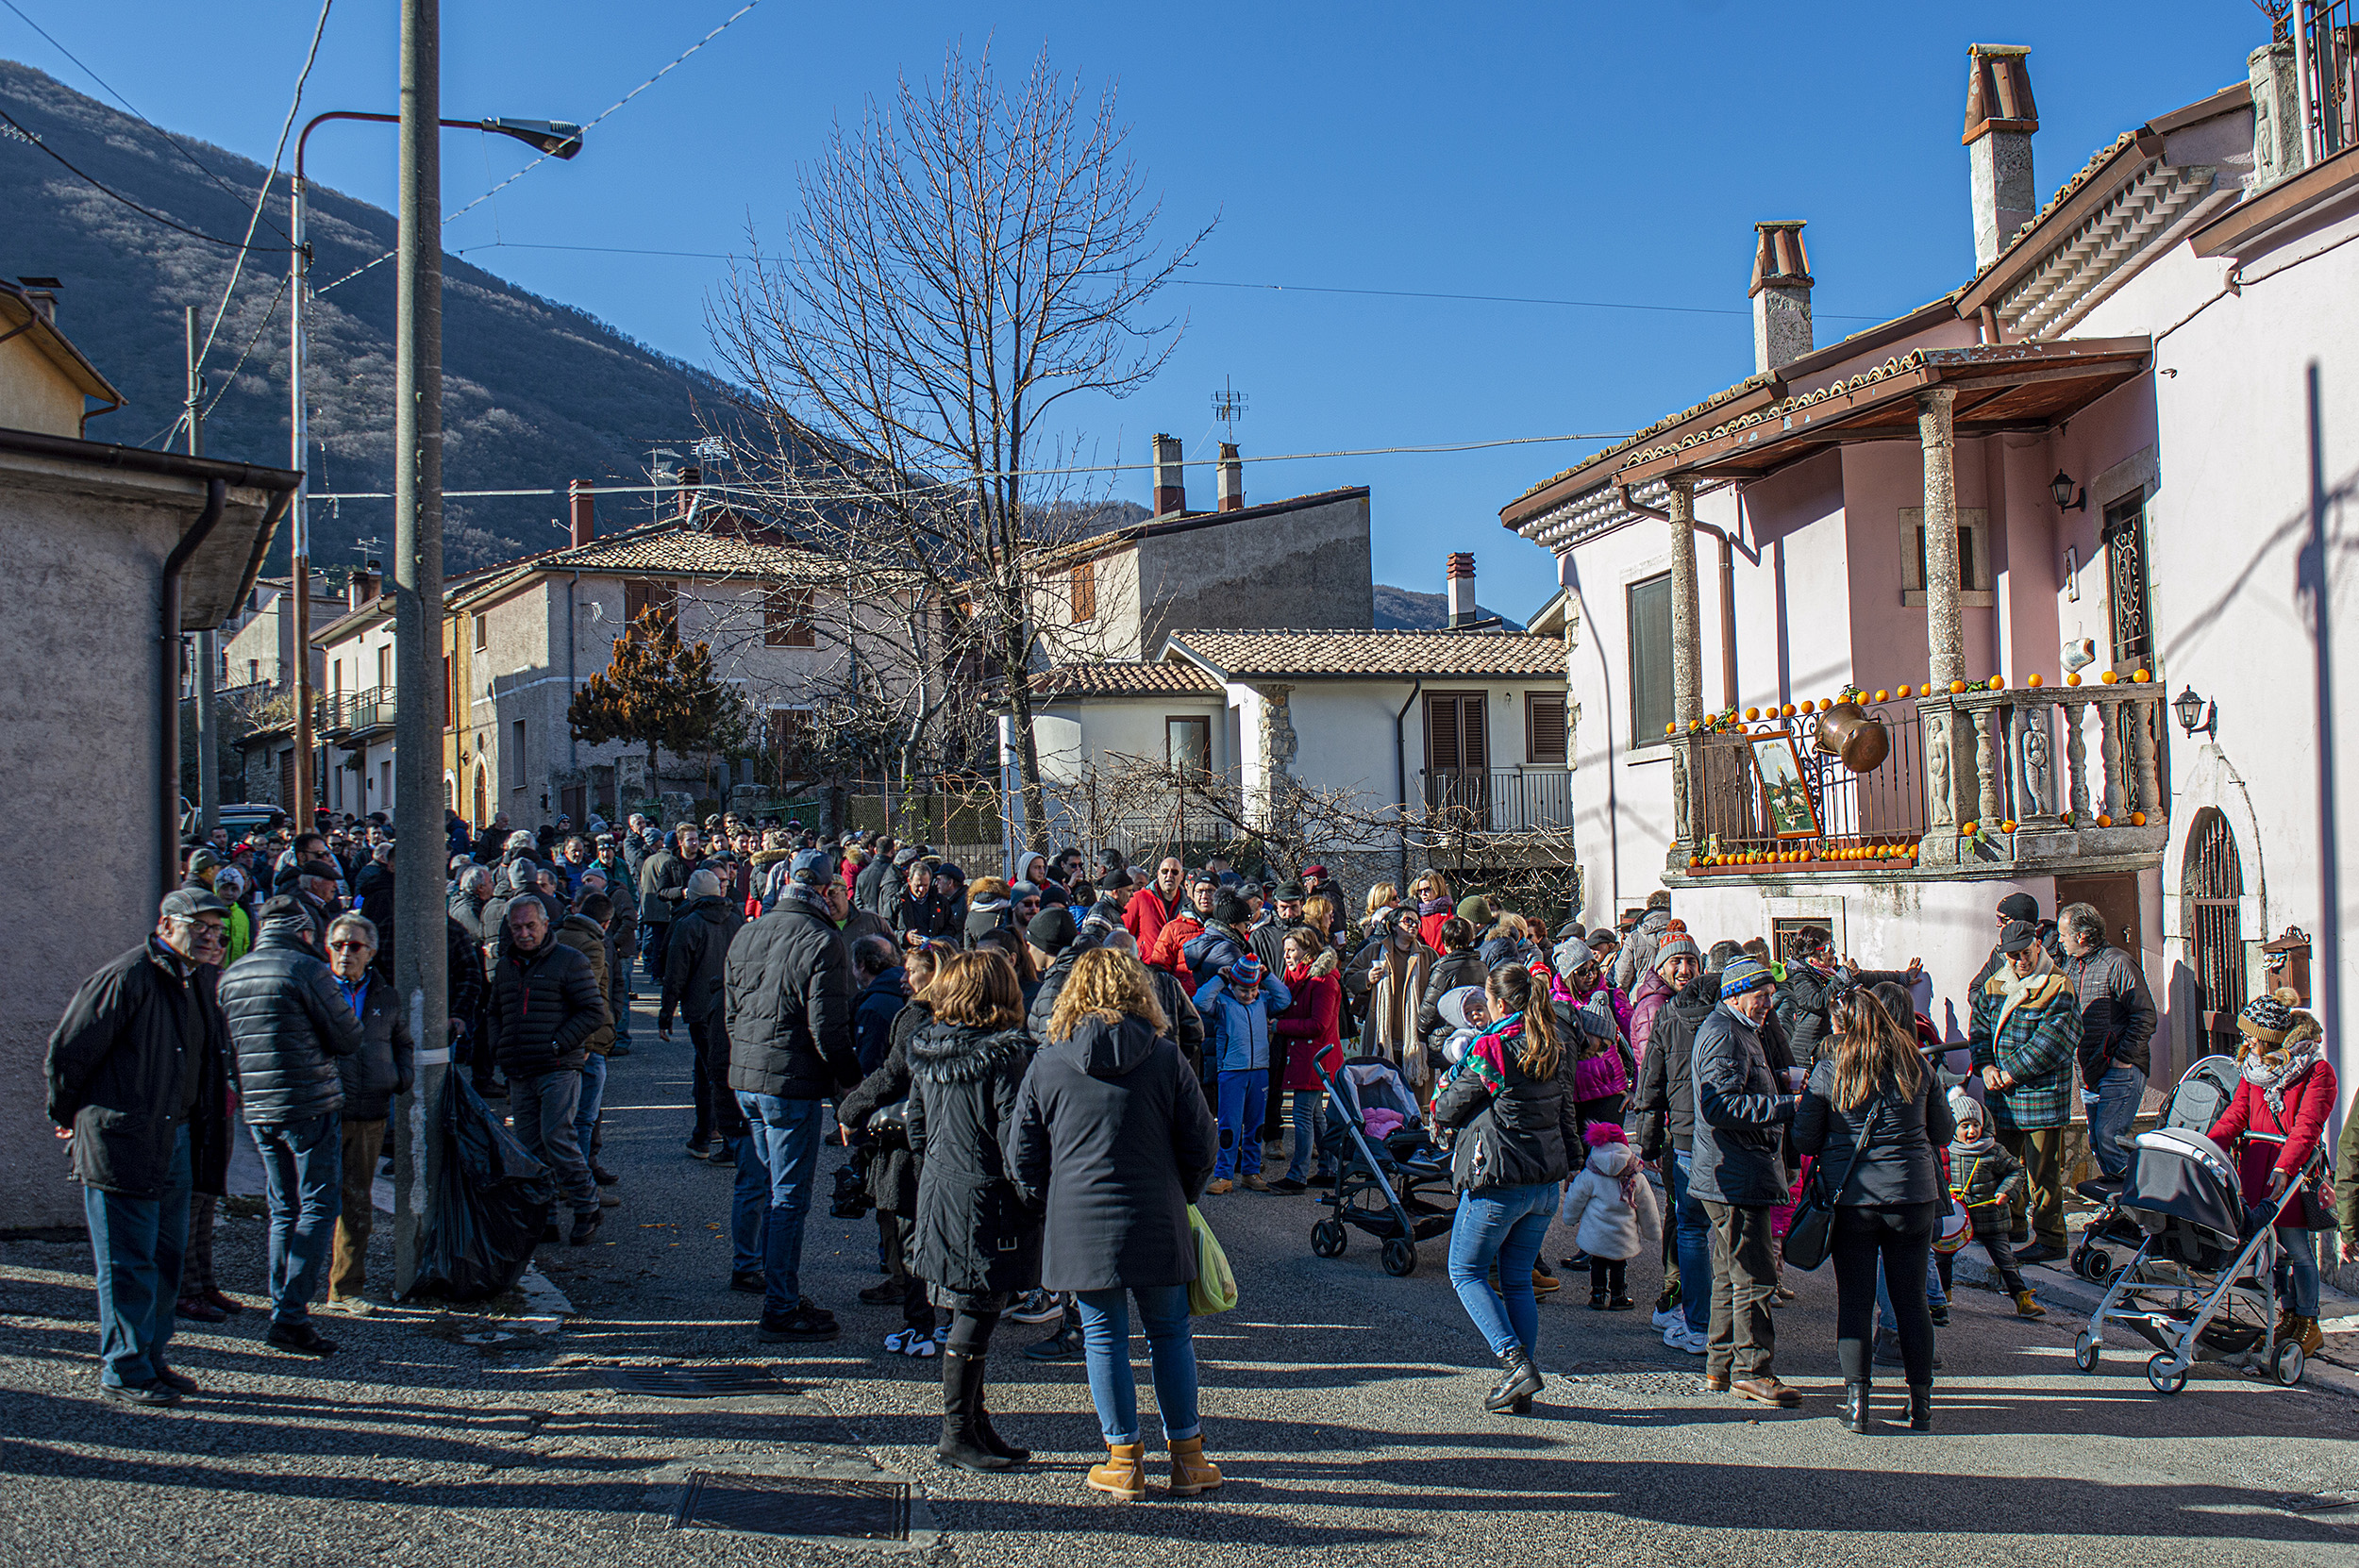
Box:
909 953 1041 1469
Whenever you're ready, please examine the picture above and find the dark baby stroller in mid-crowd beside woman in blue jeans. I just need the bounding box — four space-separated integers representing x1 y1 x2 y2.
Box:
1312 1057 1453 1278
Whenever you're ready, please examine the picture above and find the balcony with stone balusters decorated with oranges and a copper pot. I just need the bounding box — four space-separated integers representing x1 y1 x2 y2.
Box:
1670 681 2170 882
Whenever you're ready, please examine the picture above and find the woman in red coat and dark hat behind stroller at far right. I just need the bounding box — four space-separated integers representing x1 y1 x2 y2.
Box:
2211 991 2335 1356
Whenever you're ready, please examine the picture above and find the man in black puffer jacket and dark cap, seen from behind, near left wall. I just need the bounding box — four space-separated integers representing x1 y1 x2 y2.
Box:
222 893 361 1356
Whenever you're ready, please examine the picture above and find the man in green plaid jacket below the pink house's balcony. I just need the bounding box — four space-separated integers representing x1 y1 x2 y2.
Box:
1970 920 2081 1264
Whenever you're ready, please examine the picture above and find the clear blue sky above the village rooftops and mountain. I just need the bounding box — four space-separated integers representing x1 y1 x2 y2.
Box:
0 0 2267 613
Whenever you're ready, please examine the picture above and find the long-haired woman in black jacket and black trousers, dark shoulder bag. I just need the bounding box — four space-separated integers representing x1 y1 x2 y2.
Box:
1793 991 1958 1431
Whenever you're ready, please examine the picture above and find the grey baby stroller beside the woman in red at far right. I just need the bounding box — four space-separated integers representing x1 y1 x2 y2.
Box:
2074 1127 2326 1393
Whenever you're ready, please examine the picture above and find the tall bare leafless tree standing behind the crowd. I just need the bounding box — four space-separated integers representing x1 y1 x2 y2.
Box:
712 47 1211 844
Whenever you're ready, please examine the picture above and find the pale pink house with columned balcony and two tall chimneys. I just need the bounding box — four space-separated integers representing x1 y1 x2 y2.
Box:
1500 30 2359 1136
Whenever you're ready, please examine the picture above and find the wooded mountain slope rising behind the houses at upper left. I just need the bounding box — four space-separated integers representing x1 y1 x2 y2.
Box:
0 61 727 573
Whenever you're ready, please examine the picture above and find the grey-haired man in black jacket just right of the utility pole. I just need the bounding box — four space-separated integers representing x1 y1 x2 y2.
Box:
491 898 607 1247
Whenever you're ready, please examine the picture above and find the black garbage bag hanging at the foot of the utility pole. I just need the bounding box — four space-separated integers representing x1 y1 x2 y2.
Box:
409 1073 557 1302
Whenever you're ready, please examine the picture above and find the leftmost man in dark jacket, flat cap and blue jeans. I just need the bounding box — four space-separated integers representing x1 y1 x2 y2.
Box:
45 889 229 1406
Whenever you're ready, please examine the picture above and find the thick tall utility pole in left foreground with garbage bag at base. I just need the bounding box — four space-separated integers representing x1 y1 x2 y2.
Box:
394 0 451 1293
